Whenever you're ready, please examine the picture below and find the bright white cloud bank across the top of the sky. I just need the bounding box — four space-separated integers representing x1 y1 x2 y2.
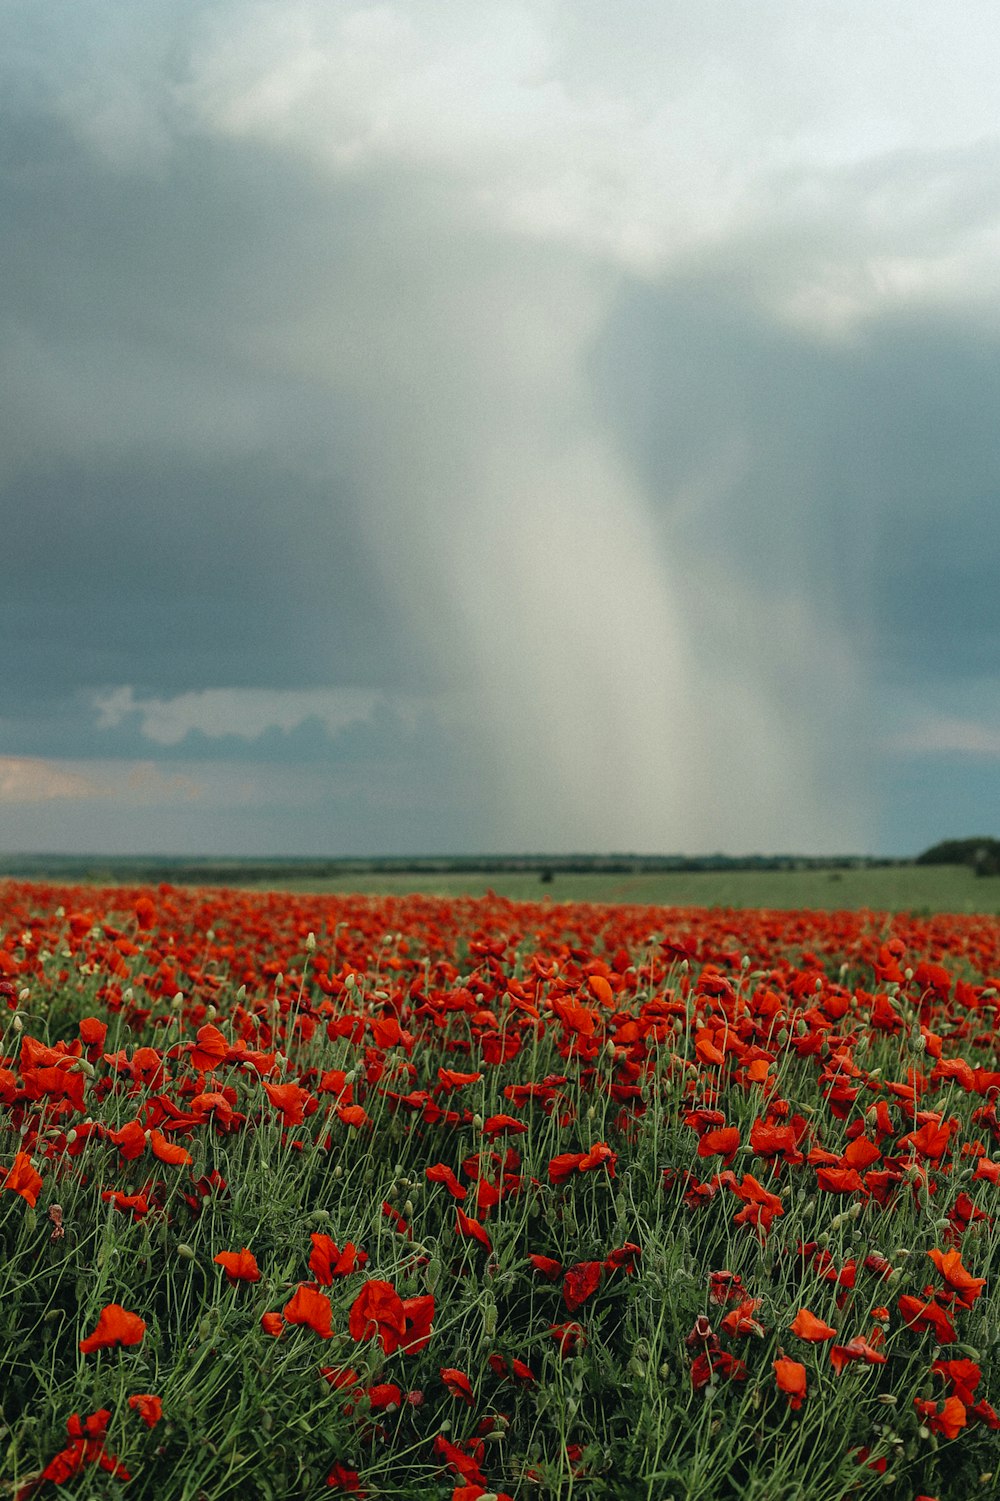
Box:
13 0 998 307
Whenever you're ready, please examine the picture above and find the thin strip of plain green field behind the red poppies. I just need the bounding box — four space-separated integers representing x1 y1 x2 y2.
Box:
243 865 1000 913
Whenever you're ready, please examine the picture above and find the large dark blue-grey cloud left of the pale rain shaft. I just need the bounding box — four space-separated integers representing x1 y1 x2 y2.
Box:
0 117 420 702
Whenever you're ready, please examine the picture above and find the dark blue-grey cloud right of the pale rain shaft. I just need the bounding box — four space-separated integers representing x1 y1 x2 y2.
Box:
593 279 1000 693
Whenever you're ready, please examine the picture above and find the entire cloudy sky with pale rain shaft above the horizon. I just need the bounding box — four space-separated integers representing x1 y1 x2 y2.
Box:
0 0 1000 854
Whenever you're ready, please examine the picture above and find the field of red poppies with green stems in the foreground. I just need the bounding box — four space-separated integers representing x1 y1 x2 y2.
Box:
0 883 1000 1501
